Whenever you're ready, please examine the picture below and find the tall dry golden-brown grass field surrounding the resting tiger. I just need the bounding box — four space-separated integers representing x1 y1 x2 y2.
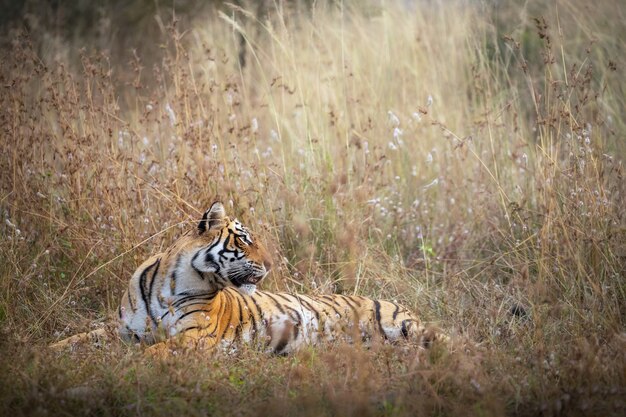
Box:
0 0 626 416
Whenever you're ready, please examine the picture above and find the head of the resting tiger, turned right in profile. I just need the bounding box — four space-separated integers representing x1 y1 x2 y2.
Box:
186 202 272 294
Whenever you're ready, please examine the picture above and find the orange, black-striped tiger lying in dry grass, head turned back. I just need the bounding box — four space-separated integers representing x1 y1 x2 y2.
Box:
51 202 448 356
